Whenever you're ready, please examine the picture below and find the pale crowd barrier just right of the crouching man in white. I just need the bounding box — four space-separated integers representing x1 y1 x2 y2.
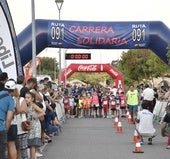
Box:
153 100 168 123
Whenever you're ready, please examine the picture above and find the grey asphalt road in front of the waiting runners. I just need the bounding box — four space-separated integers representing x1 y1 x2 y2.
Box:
41 118 170 159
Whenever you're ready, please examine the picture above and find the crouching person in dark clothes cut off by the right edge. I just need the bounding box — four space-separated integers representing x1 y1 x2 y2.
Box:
161 105 170 149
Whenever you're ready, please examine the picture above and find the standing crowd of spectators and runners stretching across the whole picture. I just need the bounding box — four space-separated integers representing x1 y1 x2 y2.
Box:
0 72 170 159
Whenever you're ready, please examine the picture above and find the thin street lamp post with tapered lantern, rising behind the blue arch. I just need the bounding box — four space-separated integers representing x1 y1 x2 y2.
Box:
55 0 64 84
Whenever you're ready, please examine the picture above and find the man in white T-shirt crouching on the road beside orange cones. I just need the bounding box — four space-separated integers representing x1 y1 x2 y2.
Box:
136 102 156 145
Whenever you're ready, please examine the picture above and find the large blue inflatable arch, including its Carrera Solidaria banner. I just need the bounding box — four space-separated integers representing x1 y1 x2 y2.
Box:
17 19 170 66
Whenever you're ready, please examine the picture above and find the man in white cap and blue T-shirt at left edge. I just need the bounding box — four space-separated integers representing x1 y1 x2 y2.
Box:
0 78 16 159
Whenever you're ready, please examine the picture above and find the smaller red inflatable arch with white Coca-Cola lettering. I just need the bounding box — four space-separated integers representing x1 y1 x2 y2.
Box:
61 63 124 90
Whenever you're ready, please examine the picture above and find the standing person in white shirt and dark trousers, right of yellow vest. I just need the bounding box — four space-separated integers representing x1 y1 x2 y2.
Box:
143 84 154 112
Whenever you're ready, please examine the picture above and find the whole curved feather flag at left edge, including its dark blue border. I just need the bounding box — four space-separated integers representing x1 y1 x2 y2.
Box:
0 0 23 80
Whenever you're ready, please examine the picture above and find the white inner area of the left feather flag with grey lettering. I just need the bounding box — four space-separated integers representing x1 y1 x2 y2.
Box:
0 2 17 80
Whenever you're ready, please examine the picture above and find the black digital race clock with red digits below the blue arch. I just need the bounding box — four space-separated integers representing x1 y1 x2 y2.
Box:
65 53 91 60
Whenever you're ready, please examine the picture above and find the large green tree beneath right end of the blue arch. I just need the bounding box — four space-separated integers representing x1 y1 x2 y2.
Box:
118 49 169 84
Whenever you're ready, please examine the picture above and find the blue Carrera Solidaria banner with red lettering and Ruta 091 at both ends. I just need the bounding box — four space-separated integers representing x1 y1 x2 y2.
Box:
48 20 149 49
